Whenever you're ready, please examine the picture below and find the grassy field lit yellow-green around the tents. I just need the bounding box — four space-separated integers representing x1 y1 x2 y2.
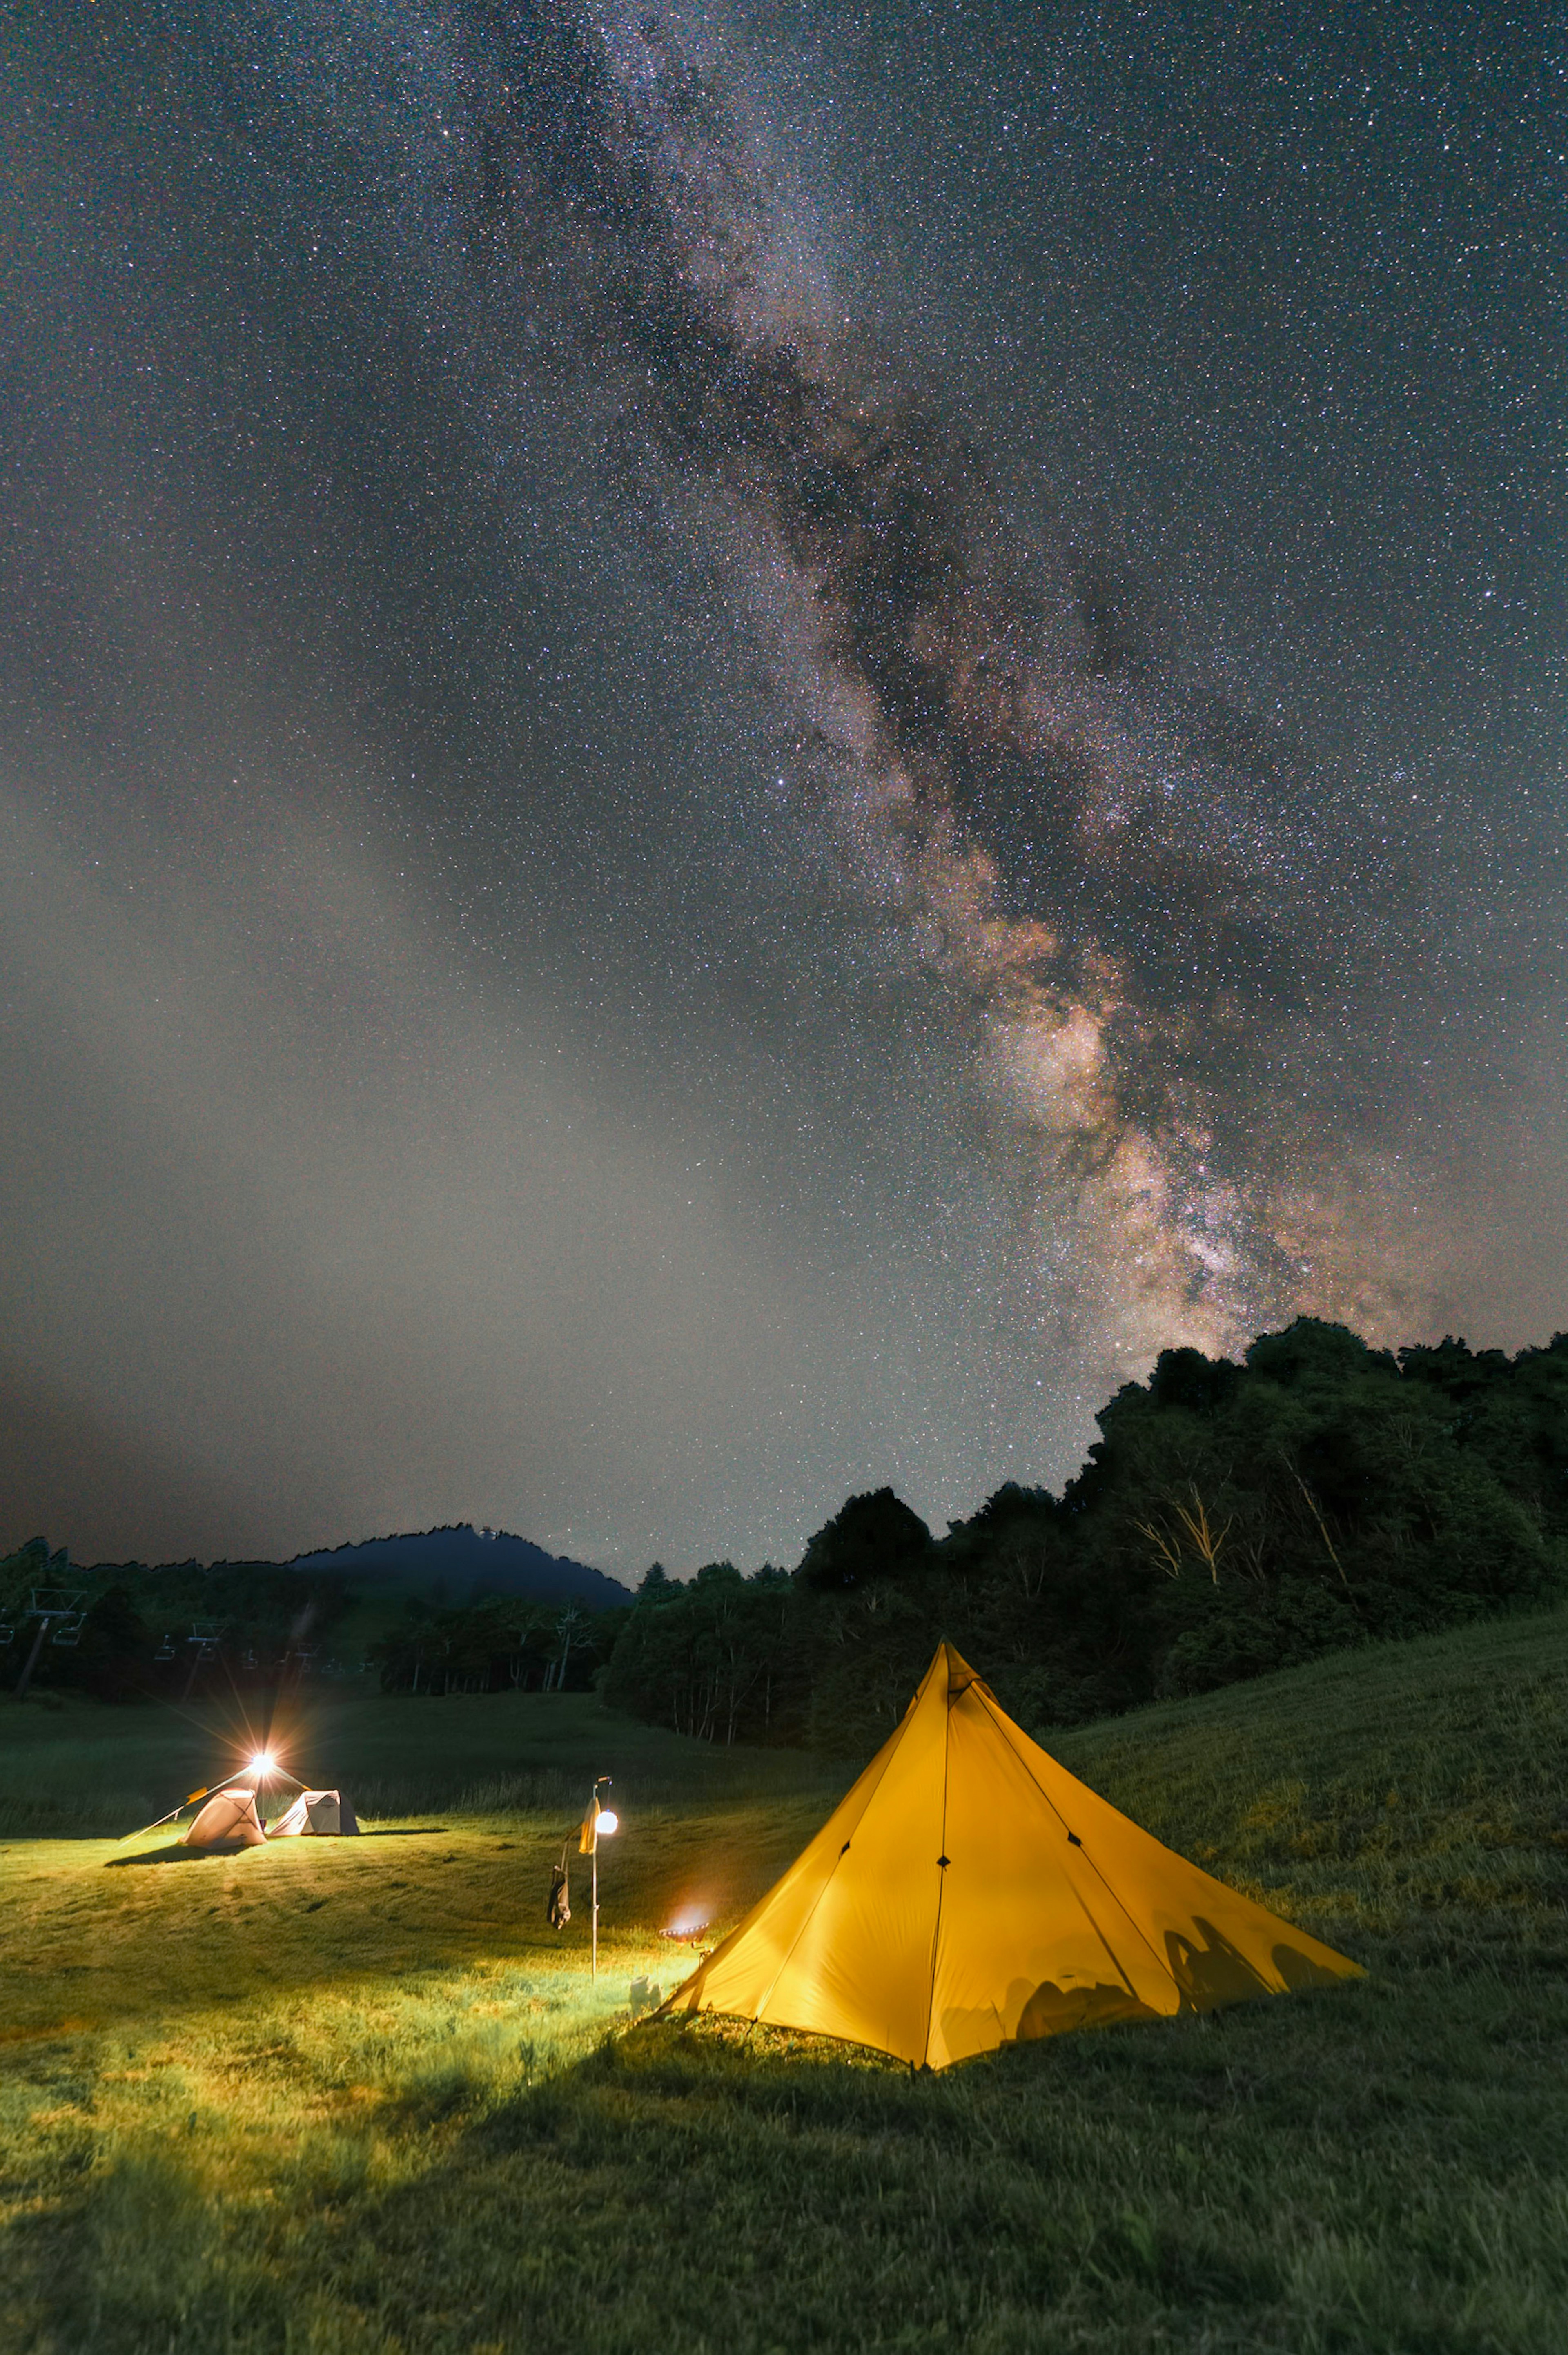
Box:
0 1613 1568 2355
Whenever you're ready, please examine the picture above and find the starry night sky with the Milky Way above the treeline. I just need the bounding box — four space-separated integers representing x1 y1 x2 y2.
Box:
0 0 1568 1573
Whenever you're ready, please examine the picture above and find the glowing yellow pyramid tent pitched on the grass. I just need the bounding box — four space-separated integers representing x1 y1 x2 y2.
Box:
664 1644 1361 2068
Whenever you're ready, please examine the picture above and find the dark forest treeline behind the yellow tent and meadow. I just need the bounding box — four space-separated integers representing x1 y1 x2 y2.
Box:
0 1319 1568 1754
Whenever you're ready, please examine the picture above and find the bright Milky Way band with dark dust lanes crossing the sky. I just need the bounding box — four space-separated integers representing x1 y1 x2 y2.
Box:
433 9 1424 1352
